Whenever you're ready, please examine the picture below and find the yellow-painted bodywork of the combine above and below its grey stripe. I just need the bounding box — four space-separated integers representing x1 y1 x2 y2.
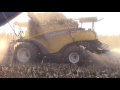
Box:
14 20 96 53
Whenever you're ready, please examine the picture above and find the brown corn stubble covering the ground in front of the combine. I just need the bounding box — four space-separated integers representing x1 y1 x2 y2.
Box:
0 63 120 78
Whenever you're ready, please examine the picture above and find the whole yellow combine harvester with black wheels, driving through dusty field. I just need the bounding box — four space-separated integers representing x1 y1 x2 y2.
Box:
12 13 108 64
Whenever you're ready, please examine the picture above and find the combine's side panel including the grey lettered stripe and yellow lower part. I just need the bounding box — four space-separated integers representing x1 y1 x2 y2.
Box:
31 29 96 53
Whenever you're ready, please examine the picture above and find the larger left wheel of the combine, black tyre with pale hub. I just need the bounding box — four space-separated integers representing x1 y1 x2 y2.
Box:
13 42 42 63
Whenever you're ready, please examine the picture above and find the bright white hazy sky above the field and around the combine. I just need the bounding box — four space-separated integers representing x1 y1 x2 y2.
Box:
0 12 120 35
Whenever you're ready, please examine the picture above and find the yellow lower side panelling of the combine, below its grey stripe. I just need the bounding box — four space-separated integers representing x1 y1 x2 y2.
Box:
24 30 96 53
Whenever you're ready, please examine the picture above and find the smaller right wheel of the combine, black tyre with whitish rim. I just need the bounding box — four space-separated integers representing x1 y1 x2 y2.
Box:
64 46 86 65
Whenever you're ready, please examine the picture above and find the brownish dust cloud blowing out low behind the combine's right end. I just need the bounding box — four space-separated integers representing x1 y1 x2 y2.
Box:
86 48 120 68
